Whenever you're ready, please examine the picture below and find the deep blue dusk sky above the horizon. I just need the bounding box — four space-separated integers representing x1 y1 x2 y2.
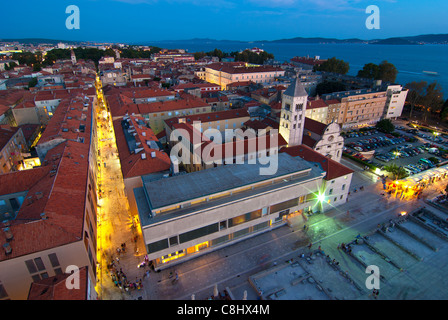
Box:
0 0 448 43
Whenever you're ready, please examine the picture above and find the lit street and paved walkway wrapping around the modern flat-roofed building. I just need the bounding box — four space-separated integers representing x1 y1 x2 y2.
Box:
90 84 443 300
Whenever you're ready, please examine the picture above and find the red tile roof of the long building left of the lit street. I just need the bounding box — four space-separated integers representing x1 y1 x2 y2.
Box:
0 94 92 261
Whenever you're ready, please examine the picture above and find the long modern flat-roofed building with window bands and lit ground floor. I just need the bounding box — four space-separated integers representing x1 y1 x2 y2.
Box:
134 153 325 269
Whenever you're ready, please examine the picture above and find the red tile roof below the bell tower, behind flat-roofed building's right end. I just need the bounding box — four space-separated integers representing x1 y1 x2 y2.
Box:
280 145 354 181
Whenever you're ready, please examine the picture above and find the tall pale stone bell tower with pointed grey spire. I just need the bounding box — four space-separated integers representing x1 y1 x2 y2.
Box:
279 78 308 147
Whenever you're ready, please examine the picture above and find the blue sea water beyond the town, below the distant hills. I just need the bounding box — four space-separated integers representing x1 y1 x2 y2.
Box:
153 41 448 99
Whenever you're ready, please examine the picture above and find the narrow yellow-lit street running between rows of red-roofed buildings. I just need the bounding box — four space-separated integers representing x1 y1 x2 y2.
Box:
96 79 149 300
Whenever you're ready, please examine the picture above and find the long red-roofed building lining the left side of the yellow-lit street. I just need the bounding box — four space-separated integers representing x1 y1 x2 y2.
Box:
0 95 98 300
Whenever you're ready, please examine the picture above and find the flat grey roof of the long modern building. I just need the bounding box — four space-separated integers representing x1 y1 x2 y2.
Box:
143 153 312 209
